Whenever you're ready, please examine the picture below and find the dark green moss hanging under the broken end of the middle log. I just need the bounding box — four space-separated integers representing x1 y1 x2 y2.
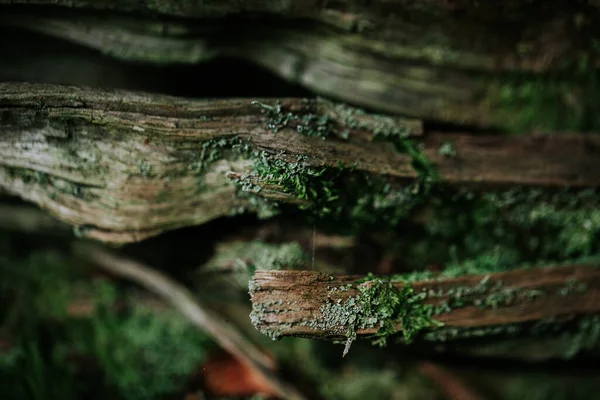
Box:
246 134 437 230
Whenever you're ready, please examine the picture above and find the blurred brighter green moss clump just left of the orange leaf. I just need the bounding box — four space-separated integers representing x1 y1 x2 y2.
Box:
84 306 210 399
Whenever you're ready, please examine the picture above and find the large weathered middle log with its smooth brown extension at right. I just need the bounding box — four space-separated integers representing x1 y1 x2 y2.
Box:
0 84 600 243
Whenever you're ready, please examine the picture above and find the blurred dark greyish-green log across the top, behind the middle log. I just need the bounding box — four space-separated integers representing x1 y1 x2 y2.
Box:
0 2 600 130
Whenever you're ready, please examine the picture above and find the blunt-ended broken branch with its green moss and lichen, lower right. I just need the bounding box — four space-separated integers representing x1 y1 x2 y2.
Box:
250 265 600 343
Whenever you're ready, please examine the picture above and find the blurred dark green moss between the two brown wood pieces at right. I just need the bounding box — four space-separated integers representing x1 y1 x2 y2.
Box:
394 188 600 277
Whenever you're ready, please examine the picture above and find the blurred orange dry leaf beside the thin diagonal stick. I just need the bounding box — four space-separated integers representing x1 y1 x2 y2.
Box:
202 353 275 397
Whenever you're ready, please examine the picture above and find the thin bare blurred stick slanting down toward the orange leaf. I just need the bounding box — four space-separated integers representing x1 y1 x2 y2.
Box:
86 246 306 400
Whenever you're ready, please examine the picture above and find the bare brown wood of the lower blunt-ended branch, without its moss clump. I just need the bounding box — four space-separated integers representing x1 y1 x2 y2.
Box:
250 266 600 339
